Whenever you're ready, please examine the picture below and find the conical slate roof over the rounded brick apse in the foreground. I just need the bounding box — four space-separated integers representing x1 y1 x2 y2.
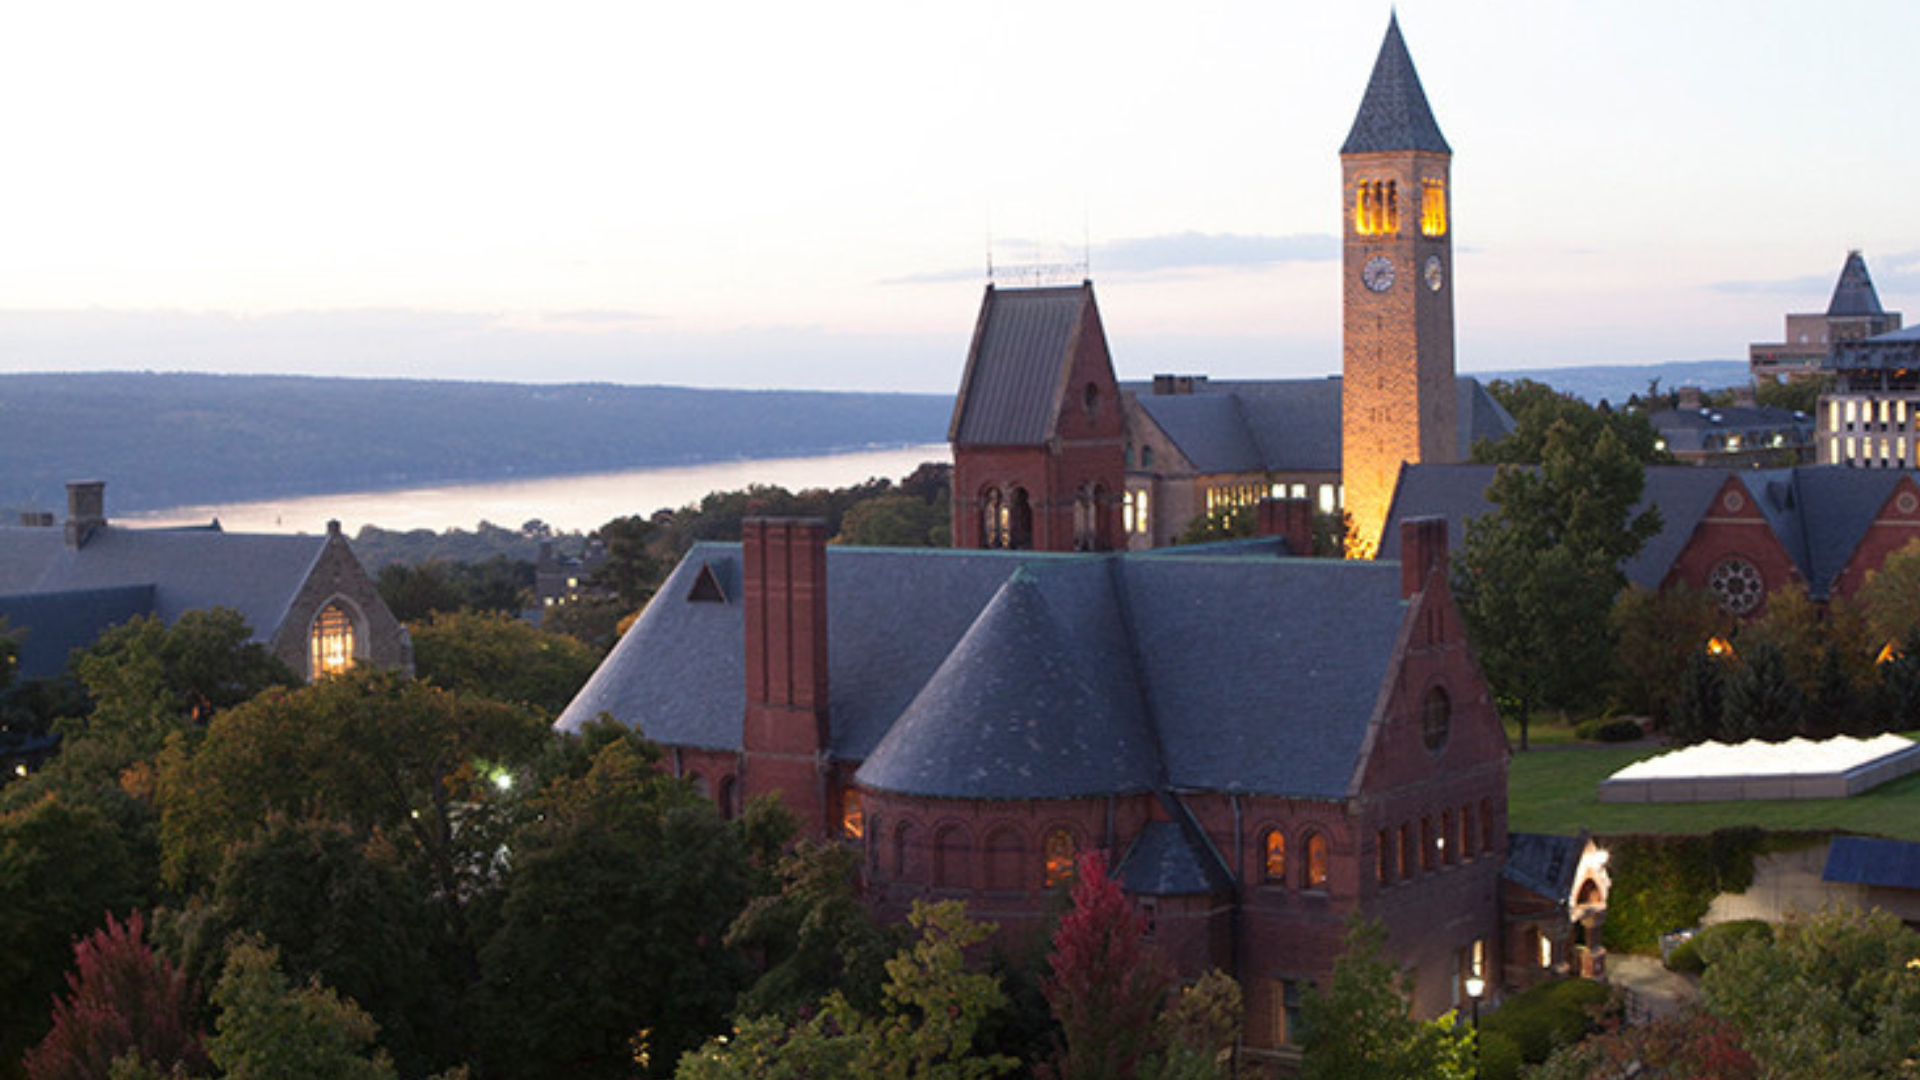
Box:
856 567 1158 799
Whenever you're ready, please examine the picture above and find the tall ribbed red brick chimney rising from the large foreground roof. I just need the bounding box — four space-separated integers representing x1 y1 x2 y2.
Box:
741 517 829 836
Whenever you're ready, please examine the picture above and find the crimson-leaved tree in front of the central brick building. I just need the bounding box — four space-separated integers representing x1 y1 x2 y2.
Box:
1043 851 1173 1080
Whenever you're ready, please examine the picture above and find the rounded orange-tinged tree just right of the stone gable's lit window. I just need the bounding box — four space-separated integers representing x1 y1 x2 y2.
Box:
409 613 601 717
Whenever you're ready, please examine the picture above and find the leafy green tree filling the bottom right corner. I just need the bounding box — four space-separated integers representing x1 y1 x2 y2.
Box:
1701 907 1920 1078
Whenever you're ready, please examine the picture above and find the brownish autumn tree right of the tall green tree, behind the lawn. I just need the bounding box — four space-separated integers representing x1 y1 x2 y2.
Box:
1607 584 1728 726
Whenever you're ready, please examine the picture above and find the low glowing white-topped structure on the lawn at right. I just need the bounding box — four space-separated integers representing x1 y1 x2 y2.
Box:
1599 734 1920 803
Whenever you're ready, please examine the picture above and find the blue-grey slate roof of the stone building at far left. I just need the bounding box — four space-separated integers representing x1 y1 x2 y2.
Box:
0 527 326 661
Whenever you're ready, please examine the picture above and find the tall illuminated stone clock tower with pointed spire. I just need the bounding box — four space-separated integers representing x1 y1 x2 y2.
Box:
1340 17 1461 557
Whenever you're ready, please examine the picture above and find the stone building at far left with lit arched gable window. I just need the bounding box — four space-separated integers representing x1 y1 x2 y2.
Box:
0 480 413 678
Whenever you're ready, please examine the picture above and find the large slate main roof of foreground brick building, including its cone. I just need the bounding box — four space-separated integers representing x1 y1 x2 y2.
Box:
557 544 1405 799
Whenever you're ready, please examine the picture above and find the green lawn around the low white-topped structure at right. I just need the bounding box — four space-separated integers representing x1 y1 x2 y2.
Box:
1507 736 1920 840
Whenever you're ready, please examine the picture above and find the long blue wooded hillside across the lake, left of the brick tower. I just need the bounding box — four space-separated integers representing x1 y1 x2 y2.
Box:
0 373 952 513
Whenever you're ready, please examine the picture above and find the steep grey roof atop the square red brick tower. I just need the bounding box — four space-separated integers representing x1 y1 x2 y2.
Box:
947 284 1092 446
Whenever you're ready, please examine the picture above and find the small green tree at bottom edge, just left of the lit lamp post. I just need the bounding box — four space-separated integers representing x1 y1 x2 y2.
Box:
1300 920 1475 1080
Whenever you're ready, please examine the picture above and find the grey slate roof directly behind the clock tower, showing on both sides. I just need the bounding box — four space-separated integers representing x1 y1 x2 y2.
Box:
1121 375 1513 473
